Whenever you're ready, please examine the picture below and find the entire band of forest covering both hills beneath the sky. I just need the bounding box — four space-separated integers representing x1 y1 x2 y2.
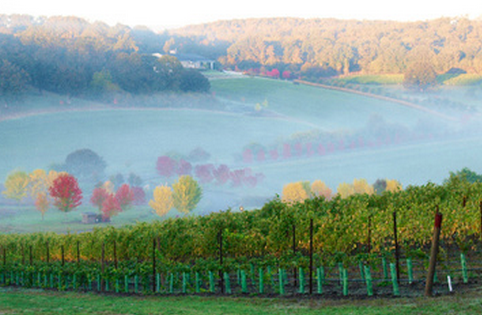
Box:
0 15 482 101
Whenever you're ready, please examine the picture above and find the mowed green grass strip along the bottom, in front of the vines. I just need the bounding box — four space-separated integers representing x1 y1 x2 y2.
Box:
0 289 482 315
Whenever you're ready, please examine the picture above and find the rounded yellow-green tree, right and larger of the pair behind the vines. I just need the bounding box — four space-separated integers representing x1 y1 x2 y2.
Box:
172 175 202 213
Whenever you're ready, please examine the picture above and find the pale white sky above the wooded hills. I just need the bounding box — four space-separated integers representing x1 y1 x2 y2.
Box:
0 0 482 30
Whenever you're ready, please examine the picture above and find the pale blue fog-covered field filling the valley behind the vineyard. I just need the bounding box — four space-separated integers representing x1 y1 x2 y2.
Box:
0 77 482 220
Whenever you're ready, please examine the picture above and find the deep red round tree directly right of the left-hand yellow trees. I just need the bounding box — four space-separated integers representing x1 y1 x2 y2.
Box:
49 174 82 213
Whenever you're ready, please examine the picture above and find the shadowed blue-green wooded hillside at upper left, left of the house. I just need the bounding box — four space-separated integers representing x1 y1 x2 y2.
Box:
0 15 210 99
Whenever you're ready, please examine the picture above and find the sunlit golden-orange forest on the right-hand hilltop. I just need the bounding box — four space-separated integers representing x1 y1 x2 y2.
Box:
171 18 482 78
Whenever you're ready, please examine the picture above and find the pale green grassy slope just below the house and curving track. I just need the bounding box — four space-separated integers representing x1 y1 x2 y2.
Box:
211 78 434 130
